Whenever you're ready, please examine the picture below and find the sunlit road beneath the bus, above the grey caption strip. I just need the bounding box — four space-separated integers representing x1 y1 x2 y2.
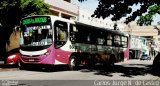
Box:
0 60 160 86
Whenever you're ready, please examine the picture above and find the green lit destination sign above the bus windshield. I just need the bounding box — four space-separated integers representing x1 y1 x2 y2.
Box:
22 17 47 25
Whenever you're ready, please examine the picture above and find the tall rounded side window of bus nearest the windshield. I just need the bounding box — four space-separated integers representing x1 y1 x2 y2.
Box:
55 21 67 48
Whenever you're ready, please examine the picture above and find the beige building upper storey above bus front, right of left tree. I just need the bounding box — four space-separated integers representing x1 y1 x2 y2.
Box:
45 0 79 19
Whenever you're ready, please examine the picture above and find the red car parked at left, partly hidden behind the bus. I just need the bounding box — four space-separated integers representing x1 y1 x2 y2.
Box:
5 48 20 67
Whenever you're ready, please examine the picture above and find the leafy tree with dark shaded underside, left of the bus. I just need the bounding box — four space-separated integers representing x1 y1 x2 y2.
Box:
0 0 49 57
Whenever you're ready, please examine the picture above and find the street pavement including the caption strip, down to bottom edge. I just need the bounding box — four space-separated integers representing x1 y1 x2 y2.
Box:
0 59 160 86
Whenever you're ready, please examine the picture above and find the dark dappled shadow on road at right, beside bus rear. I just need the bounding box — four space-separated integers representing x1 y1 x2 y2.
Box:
81 64 160 78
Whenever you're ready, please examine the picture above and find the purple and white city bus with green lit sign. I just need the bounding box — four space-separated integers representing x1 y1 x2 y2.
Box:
20 15 129 69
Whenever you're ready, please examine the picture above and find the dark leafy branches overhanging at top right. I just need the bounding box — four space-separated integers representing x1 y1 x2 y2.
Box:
79 0 160 25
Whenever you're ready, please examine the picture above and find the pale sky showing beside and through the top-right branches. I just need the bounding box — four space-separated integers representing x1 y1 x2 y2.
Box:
73 0 160 25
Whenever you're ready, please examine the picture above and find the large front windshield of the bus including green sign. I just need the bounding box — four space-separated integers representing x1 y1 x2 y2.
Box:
20 16 53 47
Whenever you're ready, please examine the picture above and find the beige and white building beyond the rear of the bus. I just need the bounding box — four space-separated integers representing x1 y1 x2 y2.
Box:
122 22 160 58
